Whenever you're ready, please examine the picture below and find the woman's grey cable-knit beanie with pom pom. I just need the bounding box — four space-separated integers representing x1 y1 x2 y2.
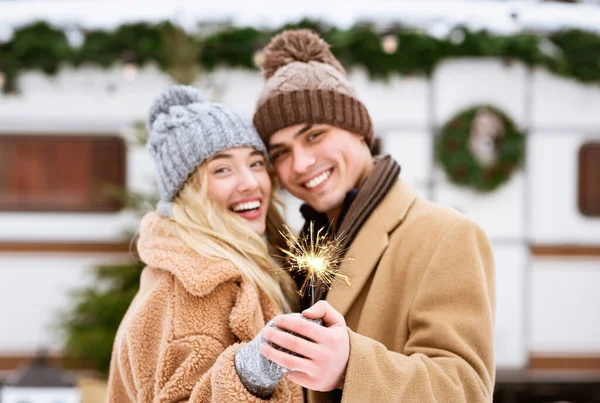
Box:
146 85 267 217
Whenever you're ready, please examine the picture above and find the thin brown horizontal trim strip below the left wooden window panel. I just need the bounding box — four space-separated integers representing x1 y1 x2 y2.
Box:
0 242 135 253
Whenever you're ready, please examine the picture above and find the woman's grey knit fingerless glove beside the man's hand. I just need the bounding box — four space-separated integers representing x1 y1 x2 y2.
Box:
235 313 322 399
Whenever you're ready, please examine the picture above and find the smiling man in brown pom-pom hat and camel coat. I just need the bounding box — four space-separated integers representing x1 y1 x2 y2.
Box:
254 30 495 403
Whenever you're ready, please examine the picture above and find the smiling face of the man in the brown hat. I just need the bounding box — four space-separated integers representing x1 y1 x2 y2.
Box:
269 124 372 213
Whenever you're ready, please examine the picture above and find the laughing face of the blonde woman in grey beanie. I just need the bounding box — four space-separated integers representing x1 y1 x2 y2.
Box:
206 147 271 235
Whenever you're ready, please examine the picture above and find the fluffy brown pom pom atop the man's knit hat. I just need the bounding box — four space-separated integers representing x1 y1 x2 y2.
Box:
262 29 345 79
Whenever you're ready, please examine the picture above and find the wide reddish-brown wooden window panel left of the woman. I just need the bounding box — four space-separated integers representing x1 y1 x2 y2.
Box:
0 135 125 212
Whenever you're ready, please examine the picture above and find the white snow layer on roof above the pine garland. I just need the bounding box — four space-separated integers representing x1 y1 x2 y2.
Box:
0 0 600 41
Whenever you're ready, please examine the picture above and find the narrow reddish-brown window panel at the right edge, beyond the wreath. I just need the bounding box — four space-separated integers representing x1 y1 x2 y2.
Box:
578 143 600 217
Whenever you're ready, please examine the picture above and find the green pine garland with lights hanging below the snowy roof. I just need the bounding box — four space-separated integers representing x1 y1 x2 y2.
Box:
0 20 600 93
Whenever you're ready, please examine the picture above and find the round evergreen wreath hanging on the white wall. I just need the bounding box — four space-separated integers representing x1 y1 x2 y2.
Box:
436 105 525 192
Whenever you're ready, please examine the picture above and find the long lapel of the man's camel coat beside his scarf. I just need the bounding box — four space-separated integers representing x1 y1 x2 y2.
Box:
326 178 417 315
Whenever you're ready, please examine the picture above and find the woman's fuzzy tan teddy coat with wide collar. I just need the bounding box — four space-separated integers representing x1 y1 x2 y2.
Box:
108 213 303 403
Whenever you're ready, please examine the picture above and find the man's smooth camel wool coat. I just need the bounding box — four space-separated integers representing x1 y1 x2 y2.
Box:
309 179 495 403
